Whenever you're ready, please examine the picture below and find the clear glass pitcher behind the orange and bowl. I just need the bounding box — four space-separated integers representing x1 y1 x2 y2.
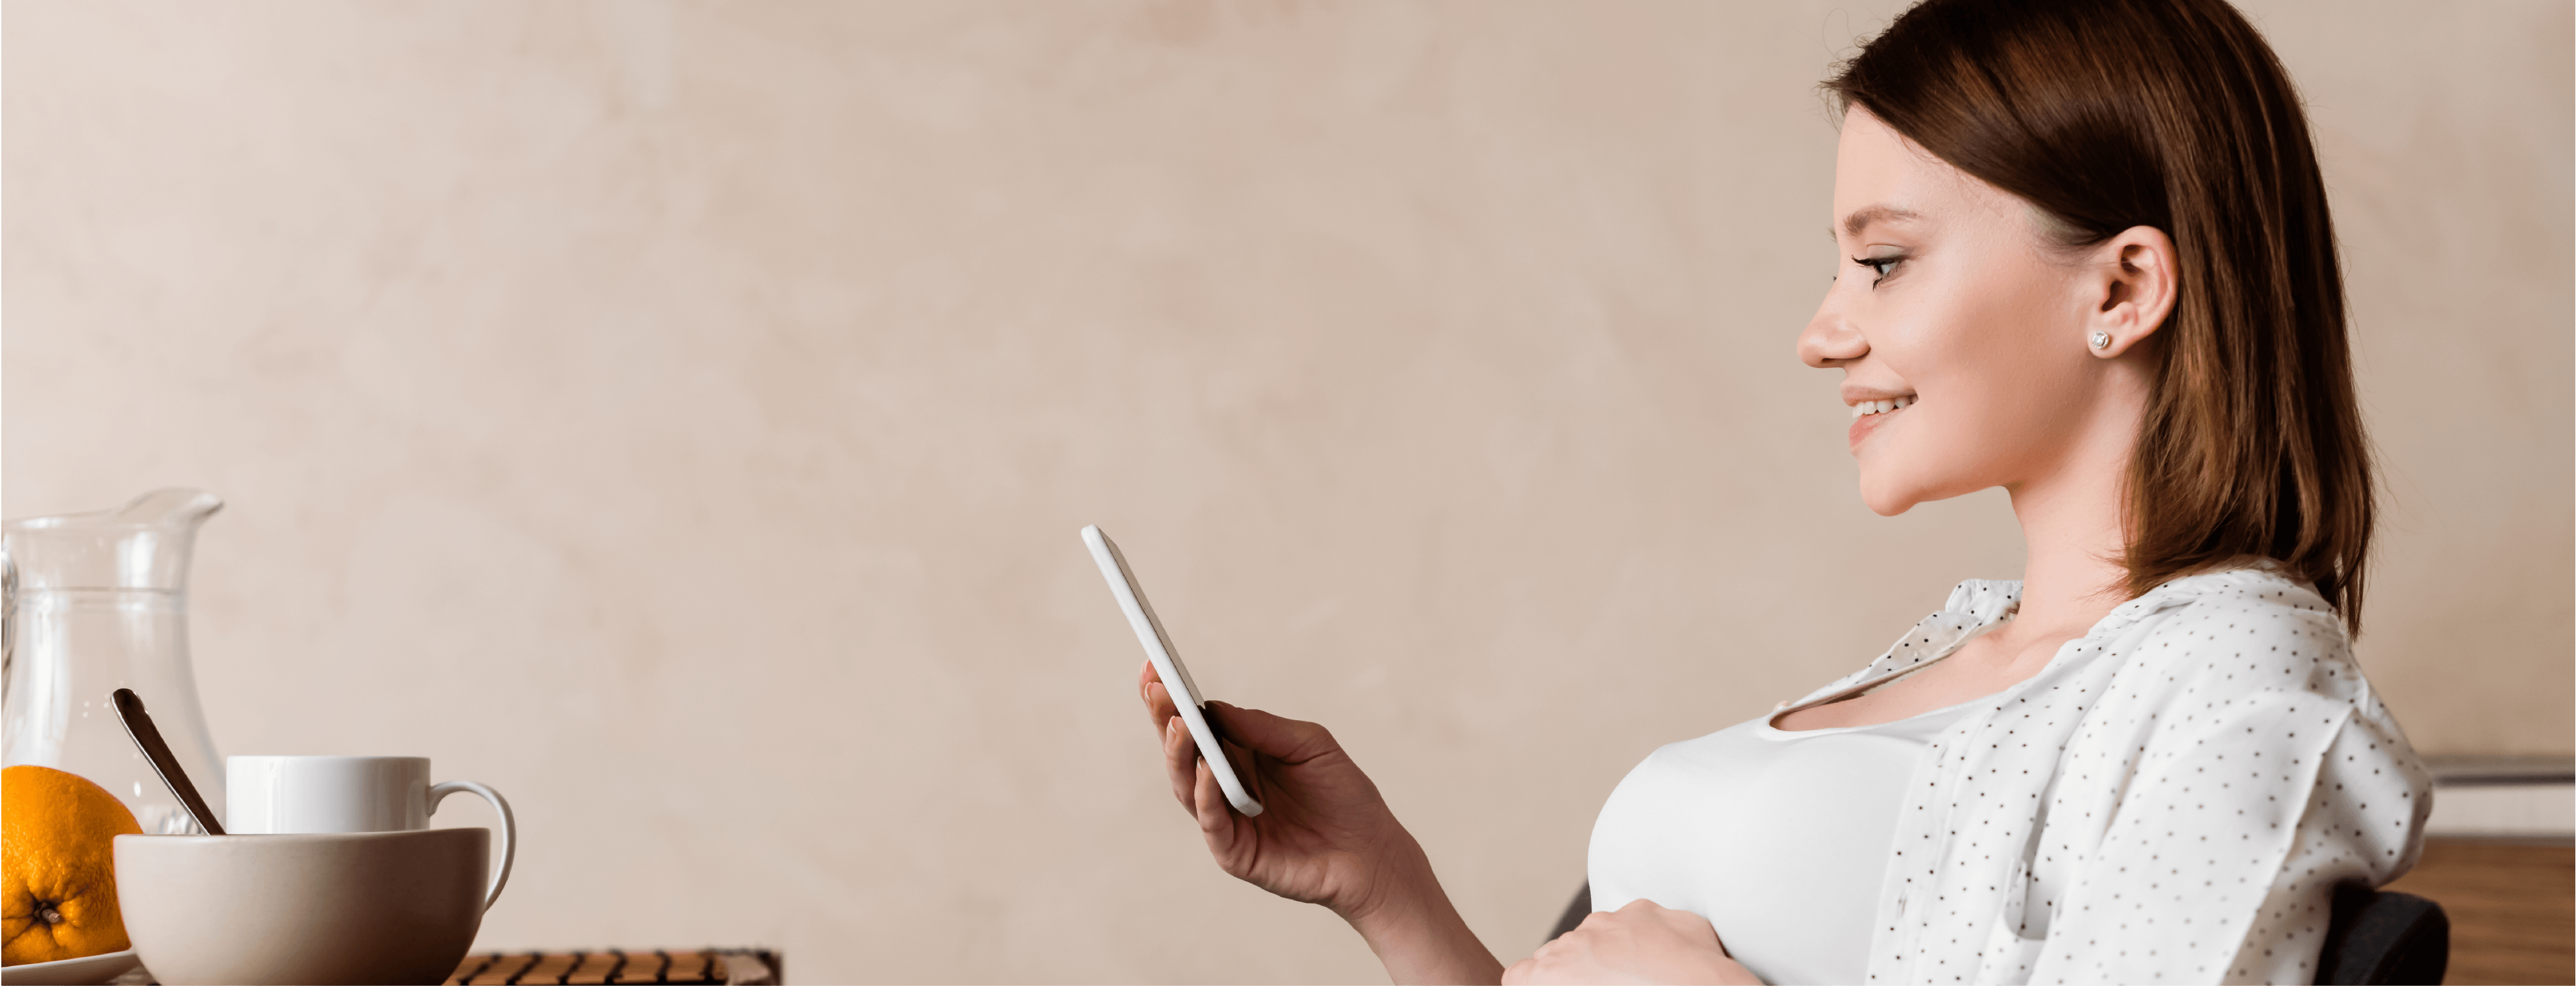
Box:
0 489 224 834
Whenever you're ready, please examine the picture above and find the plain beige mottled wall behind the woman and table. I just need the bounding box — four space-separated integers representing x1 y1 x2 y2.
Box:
0 0 2576 983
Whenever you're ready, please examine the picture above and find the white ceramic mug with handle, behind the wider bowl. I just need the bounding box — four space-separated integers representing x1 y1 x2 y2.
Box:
224 757 518 906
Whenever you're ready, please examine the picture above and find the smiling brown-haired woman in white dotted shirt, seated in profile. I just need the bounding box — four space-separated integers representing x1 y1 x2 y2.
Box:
1138 0 2429 983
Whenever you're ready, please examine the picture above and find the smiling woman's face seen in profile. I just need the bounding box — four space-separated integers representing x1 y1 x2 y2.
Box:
1798 106 2128 515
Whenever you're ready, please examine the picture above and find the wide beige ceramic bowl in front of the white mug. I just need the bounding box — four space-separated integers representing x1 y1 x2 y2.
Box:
116 829 492 986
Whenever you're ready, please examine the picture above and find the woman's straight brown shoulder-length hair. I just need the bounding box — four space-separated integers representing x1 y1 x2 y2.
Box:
1824 0 2373 631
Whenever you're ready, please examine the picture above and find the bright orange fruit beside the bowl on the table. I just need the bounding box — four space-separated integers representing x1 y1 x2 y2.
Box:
0 765 144 965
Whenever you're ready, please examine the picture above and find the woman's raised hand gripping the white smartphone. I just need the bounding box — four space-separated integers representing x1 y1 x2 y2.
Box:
1136 662 1438 924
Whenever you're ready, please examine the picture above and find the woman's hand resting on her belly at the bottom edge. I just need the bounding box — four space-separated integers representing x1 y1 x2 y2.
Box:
1502 901 1762 986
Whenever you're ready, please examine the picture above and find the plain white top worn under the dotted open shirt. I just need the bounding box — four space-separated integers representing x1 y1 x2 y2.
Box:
1592 705 1971 983
